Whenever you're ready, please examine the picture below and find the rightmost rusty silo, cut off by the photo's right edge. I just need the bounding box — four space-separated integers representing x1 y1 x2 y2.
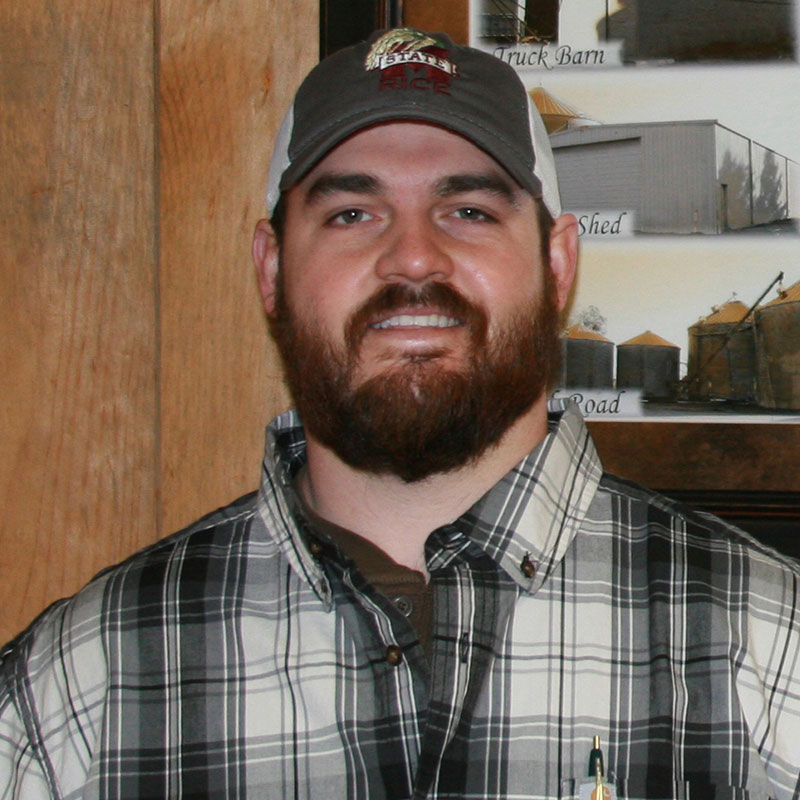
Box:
753 281 800 409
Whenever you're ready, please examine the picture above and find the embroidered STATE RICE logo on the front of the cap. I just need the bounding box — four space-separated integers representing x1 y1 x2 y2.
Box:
364 28 458 94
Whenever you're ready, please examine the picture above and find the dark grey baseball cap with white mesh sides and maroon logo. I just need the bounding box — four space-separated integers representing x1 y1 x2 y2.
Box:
267 28 561 217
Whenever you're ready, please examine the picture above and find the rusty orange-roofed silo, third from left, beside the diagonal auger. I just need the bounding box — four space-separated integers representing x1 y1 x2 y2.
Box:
686 300 756 403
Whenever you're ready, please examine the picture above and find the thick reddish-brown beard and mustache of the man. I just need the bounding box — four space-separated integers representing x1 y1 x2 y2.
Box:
270 272 561 483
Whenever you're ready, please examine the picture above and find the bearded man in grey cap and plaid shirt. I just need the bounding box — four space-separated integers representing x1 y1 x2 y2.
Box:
0 29 800 798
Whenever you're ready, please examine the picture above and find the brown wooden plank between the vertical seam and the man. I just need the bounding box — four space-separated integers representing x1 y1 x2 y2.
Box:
159 0 318 532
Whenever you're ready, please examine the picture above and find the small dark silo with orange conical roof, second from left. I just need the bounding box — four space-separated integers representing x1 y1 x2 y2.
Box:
617 331 681 400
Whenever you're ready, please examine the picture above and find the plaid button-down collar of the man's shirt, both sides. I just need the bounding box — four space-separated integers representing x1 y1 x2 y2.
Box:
259 400 602 605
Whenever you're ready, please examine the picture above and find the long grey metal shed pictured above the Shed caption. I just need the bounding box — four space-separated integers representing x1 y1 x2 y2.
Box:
550 120 800 233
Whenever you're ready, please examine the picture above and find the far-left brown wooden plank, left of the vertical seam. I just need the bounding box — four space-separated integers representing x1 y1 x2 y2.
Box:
0 0 157 640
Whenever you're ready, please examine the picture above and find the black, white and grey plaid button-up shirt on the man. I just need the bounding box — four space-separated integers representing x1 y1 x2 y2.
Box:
0 408 800 800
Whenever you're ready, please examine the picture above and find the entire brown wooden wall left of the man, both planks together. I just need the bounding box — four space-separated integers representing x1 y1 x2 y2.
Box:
0 0 318 640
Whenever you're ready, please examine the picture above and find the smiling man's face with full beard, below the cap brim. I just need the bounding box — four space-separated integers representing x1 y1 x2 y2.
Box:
266 123 566 481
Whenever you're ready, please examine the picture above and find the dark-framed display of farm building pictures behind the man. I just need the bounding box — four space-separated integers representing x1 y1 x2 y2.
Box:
468 0 800 533
